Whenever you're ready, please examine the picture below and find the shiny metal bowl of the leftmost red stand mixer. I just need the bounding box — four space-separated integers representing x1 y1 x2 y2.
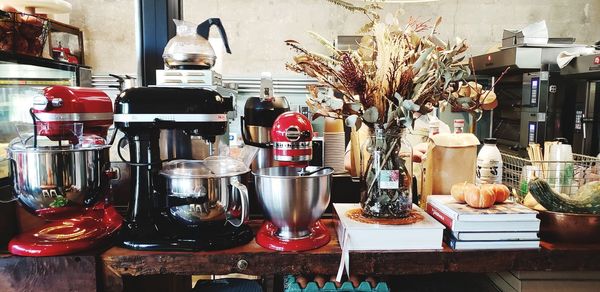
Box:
8 144 110 215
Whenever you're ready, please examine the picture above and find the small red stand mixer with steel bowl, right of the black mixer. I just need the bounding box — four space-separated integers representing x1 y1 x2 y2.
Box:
253 112 333 251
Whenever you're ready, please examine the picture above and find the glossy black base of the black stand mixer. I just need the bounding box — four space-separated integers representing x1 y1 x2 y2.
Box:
121 225 254 251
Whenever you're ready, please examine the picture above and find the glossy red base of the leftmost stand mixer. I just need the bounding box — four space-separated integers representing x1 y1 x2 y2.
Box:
8 207 122 256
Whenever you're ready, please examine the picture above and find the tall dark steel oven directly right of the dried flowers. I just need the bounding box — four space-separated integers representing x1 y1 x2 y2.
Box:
473 46 584 155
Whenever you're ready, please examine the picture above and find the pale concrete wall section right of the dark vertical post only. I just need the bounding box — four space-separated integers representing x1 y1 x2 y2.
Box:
184 0 600 75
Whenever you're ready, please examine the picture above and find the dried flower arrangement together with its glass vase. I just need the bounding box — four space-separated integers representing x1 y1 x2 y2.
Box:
286 0 496 218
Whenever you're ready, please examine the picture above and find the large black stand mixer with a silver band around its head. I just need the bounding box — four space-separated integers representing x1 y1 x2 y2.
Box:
114 87 253 250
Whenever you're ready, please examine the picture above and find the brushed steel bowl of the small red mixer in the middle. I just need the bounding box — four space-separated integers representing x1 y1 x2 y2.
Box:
253 167 333 239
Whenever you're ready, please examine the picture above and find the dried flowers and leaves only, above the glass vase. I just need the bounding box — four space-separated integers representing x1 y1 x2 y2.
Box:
286 0 471 128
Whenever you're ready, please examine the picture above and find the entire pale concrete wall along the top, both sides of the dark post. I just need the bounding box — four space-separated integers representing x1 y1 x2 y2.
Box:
63 0 600 75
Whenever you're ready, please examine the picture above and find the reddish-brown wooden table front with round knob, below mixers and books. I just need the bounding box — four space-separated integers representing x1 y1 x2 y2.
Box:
100 220 600 291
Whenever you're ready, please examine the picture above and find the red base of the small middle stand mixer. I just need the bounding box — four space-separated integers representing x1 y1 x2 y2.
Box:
256 220 331 251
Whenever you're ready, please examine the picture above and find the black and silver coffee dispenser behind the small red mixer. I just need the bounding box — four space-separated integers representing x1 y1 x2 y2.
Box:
240 72 290 170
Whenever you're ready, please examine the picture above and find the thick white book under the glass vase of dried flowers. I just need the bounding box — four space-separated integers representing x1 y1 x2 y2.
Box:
333 203 444 250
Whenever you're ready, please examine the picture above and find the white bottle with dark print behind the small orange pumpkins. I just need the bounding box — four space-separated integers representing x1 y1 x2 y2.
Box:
477 138 502 184
